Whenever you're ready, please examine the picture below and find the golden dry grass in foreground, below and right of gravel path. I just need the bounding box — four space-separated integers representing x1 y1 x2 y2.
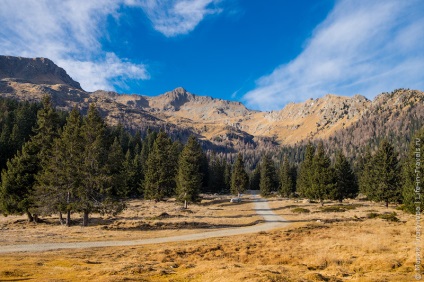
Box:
0 199 415 282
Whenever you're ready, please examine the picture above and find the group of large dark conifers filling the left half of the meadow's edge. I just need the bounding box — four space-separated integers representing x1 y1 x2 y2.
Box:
0 96 208 226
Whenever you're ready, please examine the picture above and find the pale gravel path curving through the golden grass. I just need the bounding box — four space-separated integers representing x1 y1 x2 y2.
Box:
0 196 289 253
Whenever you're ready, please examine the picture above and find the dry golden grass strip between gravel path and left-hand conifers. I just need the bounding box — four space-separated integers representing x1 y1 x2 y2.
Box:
0 196 262 246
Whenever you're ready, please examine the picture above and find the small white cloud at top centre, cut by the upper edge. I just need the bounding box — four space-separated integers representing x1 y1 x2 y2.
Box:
126 0 221 37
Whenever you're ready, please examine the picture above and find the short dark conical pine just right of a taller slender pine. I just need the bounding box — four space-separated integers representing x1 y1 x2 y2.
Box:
330 151 358 202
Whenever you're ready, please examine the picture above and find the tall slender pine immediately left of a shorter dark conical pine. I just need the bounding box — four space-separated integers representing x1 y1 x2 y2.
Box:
307 142 334 205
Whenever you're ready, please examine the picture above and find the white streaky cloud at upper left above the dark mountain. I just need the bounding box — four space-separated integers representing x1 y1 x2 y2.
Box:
0 0 149 91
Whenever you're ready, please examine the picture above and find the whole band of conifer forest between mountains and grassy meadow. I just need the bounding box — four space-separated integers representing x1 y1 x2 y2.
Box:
0 96 424 226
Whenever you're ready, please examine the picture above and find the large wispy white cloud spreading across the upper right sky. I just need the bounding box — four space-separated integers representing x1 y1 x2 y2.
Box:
243 0 424 110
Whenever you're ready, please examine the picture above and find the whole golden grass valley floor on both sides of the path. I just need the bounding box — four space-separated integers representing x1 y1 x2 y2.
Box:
0 194 415 281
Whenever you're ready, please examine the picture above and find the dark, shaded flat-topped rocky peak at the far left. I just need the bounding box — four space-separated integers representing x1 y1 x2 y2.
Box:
0 56 81 89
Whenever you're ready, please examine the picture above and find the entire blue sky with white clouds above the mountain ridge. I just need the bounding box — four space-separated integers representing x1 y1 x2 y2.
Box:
0 0 424 110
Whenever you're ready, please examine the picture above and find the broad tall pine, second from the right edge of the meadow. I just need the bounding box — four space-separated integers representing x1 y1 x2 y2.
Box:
369 140 402 207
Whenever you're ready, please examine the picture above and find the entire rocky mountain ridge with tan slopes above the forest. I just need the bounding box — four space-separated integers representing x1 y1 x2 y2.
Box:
0 53 424 147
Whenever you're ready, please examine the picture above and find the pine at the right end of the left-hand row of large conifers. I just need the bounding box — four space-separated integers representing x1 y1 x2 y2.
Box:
177 136 203 208
